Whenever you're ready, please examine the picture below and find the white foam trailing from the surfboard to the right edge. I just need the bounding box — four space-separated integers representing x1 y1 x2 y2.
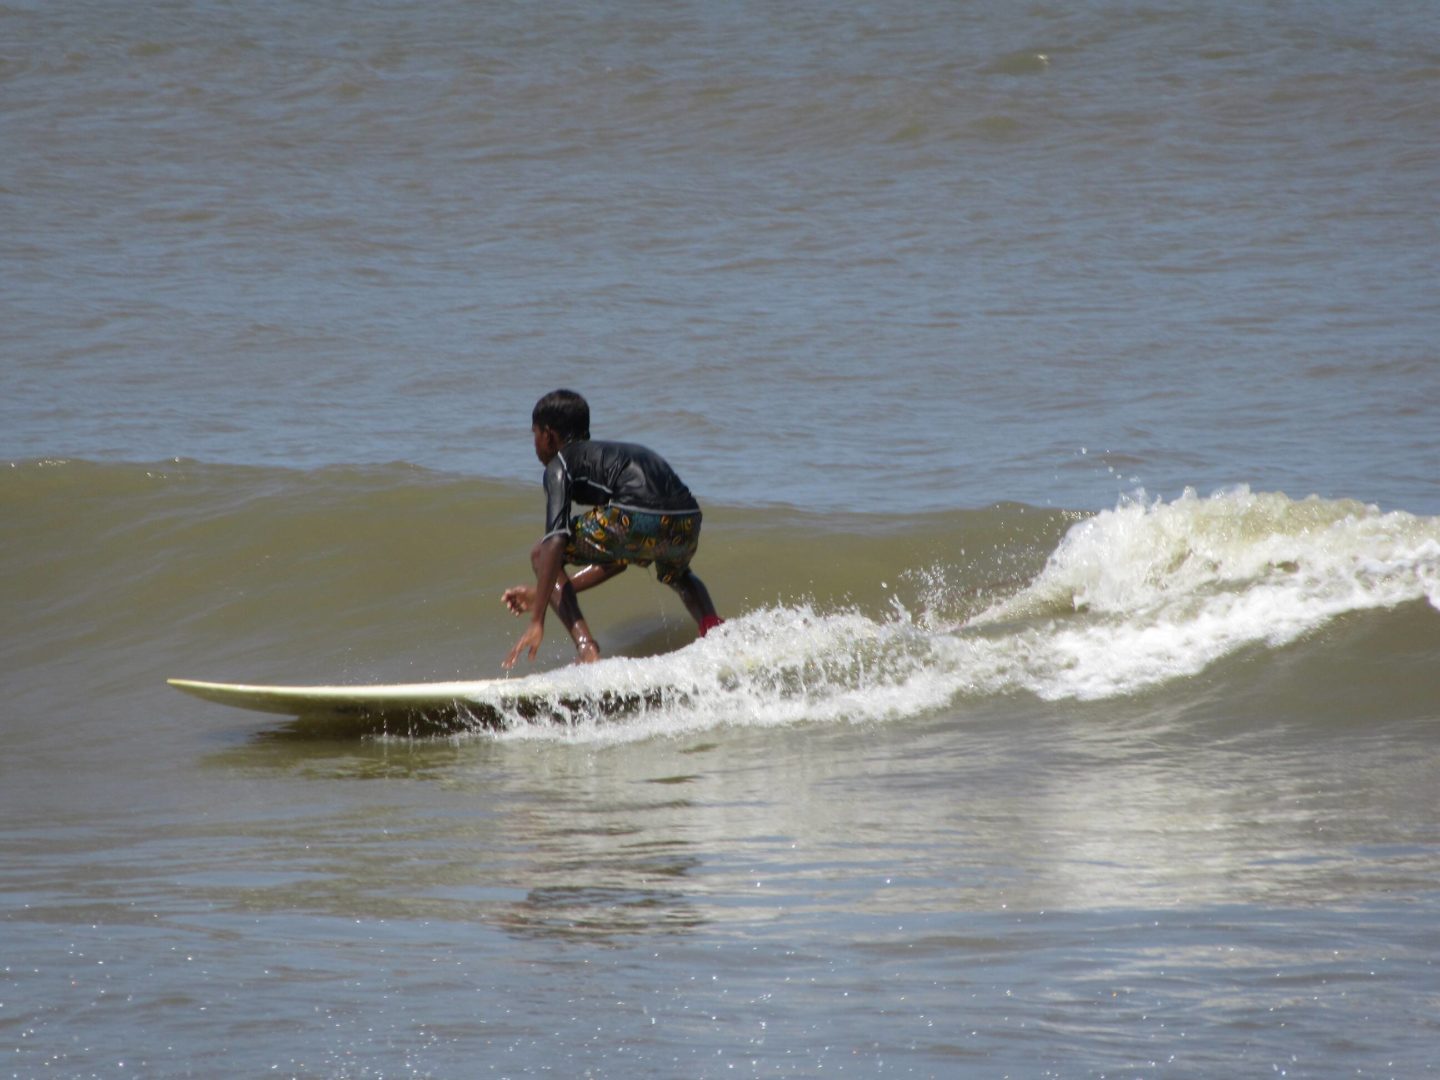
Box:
486 488 1440 742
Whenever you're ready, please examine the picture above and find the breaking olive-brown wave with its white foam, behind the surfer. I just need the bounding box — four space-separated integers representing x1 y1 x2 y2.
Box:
3 462 1440 739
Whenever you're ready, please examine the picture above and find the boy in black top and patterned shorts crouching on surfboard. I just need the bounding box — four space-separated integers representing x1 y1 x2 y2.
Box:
501 390 721 668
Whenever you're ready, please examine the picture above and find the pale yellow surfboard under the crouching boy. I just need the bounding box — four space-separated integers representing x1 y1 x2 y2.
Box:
167 675 665 733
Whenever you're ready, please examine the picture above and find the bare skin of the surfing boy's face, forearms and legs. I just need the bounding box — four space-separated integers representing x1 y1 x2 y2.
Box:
500 426 716 670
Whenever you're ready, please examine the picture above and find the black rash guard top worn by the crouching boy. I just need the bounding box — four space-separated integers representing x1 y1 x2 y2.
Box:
544 439 700 539
